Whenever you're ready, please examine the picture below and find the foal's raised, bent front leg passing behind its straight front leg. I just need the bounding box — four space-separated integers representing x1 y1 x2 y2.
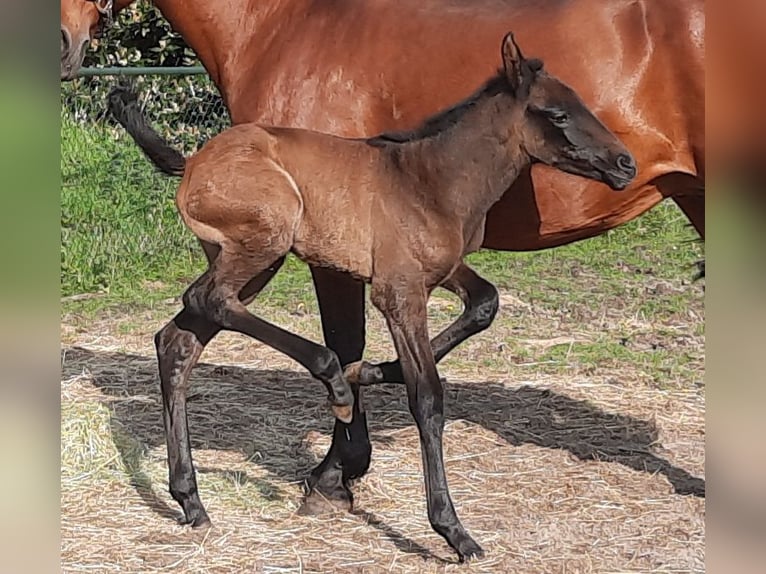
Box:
346 263 498 385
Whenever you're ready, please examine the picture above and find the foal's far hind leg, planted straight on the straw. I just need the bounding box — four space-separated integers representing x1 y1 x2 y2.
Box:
154 254 284 526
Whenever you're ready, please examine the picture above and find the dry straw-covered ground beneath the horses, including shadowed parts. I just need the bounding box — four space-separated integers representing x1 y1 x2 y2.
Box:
61 272 705 574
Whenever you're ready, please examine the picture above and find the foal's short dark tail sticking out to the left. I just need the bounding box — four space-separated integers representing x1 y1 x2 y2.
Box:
107 85 186 176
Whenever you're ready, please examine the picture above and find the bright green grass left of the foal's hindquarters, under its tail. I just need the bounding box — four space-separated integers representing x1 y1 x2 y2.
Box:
61 110 202 302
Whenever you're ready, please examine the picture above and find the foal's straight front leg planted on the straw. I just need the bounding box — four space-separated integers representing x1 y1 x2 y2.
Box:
372 277 483 561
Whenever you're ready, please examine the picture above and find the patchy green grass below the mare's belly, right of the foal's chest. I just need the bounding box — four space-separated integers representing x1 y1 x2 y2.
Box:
467 202 702 316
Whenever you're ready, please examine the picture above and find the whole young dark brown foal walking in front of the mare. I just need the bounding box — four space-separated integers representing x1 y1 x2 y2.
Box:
110 33 636 561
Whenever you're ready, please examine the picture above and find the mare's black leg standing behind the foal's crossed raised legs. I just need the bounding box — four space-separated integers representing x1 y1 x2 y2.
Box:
300 267 372 514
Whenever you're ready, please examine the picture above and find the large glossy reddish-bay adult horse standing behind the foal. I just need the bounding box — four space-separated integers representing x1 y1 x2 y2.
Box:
61 0 705 511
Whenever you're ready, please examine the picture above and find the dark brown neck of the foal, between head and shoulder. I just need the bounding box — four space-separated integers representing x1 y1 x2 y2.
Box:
400 92 531 226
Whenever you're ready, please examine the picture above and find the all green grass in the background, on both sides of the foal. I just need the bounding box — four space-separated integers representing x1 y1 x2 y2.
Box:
61 113 702 324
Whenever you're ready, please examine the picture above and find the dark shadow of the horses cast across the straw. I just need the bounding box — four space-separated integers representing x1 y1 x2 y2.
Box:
62 347 705 555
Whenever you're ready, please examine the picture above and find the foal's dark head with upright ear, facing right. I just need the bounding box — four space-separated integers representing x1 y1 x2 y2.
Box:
502 33 636 190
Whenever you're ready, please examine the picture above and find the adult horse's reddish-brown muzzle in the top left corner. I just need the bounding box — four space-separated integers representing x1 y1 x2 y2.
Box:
61 0 124 81
